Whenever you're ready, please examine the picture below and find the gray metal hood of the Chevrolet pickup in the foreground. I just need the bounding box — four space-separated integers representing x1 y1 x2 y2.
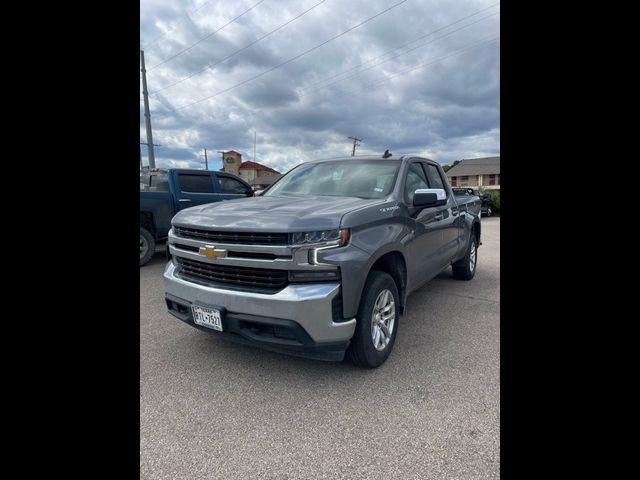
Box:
172 196 384 232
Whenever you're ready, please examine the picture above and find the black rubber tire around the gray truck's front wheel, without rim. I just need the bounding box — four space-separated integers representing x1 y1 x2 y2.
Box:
346 270 400 368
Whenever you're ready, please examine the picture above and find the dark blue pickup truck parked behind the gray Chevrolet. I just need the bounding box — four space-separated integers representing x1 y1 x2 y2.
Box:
140 169 253 266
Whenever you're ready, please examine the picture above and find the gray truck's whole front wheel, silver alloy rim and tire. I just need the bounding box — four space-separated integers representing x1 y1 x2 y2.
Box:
347 270 400 368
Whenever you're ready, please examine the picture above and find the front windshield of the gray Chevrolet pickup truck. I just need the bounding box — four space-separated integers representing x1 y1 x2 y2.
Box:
264 160 400 198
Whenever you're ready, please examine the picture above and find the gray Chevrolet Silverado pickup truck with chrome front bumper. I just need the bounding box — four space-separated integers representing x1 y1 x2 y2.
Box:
164 154 480 368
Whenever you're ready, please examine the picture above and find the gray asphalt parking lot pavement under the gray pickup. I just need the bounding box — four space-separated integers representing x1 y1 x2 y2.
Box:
140 217 500 480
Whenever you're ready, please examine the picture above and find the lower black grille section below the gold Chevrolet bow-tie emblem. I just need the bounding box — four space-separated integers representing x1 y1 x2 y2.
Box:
175 257 289 289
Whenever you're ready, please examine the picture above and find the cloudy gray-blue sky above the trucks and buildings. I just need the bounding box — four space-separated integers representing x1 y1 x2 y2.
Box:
140 0 500 172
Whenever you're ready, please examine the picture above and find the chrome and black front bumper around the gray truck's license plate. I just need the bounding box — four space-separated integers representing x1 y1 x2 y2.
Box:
164 262 356 360
